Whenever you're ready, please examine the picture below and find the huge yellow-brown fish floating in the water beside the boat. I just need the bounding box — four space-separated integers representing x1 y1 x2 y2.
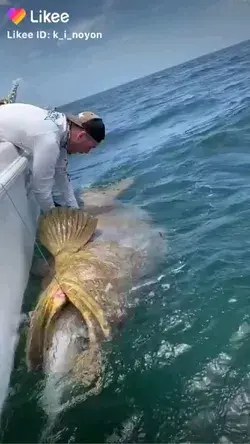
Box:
26 180 165 398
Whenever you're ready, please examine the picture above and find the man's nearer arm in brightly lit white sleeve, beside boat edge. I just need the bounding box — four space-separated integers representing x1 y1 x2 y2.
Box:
32 133 60 212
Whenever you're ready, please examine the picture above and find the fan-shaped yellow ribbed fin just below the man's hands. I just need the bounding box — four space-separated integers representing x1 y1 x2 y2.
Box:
38 207 98 256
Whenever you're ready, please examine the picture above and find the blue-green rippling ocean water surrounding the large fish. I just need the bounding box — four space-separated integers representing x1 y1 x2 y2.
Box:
1 42 250 443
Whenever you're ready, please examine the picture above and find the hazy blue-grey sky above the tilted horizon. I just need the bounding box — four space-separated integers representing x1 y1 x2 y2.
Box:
0 0 250 106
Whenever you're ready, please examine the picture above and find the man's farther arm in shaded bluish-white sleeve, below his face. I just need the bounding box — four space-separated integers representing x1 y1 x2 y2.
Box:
53 148 79 208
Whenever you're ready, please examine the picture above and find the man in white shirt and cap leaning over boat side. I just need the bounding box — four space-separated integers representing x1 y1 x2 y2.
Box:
0 103 105 212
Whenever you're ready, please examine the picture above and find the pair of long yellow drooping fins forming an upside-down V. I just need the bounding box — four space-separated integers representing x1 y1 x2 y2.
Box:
26 279 109 374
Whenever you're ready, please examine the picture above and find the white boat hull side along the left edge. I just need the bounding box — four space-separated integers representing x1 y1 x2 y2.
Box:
0 142 39 415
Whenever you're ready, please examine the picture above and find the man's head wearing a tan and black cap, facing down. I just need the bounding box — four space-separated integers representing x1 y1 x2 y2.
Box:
66 111 105 154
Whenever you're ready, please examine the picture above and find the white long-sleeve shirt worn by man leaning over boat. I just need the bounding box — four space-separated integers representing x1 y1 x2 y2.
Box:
0 103 78 212
